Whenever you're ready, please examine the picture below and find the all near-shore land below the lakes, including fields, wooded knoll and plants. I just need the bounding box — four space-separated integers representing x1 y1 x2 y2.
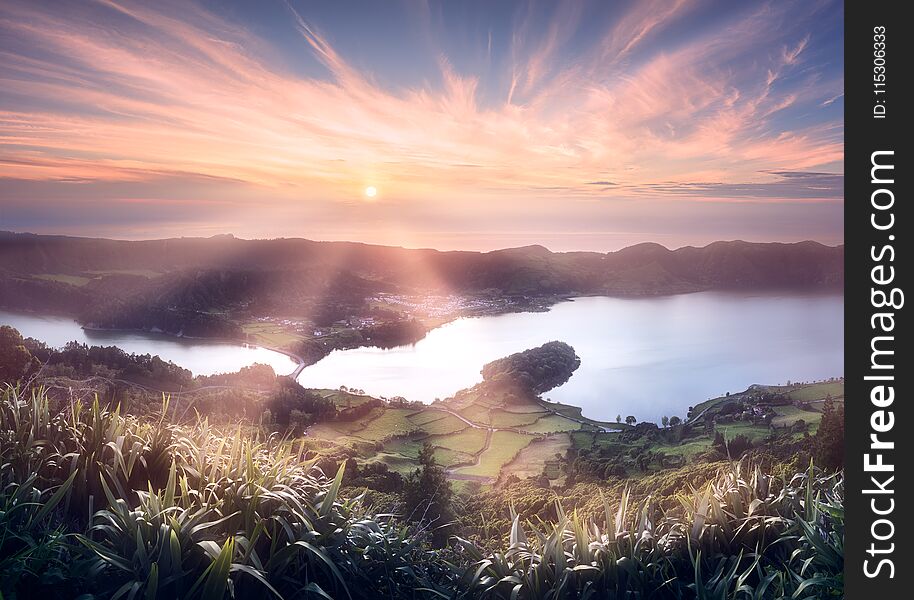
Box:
0 327 843 600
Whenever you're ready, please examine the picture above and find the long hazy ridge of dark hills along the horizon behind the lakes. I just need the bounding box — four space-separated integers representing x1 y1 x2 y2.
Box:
0 232 844 295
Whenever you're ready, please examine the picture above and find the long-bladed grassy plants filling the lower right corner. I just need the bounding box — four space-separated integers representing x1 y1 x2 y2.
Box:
465 465 844 600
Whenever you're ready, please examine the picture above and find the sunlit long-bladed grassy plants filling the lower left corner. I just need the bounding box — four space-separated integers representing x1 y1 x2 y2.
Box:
0 388 449 600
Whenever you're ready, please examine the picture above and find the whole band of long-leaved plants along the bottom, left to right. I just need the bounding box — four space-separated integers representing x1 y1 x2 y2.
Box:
0 387 843 599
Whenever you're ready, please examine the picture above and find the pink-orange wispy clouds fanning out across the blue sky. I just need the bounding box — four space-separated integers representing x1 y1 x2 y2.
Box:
0 0 843 248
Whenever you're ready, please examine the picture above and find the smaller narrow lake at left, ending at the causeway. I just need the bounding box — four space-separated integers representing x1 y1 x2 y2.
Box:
0 311 297 375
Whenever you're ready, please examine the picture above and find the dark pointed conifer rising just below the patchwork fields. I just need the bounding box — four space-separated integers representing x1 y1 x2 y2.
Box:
403 442 454 546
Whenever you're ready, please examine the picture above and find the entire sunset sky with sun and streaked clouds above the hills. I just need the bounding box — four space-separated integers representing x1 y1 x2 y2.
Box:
0 0 844 251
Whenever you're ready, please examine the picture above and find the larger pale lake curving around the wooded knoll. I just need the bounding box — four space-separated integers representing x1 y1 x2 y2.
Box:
298 292 844 421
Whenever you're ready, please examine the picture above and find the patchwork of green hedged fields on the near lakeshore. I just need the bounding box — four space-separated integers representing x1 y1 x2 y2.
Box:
308 382 843 482
